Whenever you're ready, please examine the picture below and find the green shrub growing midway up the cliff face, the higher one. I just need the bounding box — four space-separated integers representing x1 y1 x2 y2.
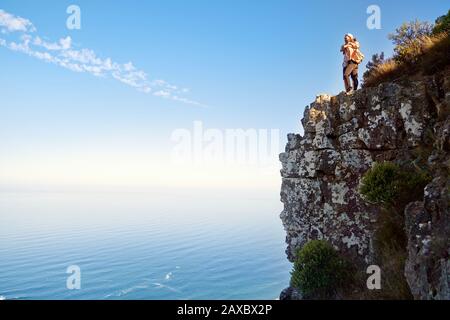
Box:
359 162 430 206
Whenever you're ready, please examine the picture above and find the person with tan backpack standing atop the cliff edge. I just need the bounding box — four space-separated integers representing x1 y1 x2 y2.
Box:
341 33 364 93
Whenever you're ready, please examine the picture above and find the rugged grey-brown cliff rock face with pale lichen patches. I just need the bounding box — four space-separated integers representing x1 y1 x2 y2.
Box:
280 72 450 299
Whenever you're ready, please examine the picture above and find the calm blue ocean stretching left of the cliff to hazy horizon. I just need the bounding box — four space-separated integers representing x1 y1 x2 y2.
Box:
0 191 291 299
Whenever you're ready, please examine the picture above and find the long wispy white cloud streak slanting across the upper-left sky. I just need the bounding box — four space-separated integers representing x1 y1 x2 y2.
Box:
0 9 206 107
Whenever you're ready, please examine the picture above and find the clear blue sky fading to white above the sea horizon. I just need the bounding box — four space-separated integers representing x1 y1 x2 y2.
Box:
0 0 448 188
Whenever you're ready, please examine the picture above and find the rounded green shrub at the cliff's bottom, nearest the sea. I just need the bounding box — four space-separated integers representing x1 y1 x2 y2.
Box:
291 240 350 299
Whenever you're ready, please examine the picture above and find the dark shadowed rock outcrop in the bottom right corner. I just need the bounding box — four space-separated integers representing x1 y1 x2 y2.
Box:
405 177 450 300
